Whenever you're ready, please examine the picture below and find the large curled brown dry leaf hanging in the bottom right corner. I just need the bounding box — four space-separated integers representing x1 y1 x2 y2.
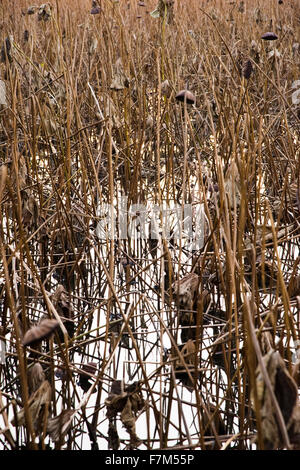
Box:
252 349 300 450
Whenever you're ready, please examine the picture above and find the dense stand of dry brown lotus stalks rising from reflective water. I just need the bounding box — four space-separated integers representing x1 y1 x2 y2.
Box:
0 0 300 449
